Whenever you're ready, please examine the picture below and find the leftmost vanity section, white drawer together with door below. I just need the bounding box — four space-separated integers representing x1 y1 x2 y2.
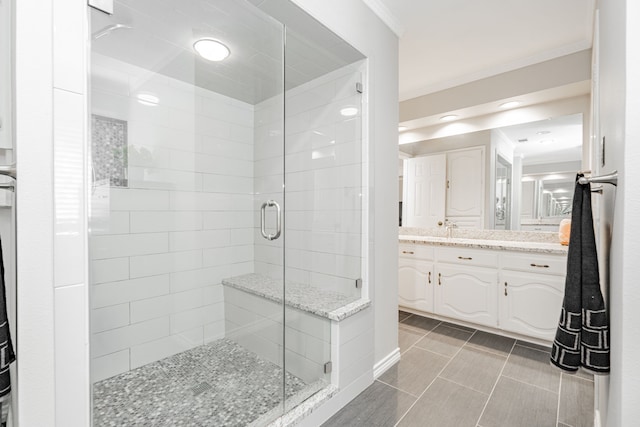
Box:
398 245 434 313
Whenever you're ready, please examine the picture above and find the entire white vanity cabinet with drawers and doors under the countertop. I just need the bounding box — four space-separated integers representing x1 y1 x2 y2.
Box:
398 243 566 341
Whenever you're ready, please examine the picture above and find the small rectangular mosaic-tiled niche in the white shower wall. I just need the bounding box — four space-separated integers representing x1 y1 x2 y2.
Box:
91 114 128 187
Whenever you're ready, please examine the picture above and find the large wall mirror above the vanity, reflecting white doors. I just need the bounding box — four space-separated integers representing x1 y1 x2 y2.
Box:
399 113 583 231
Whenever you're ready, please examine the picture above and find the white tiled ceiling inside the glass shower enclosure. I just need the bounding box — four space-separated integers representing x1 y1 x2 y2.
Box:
91 0 364 104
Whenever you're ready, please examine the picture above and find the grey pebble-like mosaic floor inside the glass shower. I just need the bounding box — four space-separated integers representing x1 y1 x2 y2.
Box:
93 339 320 427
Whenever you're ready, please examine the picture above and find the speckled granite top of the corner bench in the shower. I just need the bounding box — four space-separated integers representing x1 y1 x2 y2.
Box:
222 273 371 322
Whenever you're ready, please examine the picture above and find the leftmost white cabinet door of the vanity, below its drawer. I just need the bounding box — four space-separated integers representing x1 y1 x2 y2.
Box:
398 258 433 313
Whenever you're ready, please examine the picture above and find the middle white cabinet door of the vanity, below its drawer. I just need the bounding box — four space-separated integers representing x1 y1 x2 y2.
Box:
434 263 498 327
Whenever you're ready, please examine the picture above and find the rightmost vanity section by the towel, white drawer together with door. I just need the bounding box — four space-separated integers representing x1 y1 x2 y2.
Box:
499 254 566 341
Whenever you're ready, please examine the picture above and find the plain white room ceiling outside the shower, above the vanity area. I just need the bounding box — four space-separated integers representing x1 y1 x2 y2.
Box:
372 0 594 101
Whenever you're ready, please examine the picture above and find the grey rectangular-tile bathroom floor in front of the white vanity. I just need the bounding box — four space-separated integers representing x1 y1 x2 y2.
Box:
323 311 593 427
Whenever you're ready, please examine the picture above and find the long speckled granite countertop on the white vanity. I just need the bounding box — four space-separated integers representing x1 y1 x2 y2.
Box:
399 234 568 255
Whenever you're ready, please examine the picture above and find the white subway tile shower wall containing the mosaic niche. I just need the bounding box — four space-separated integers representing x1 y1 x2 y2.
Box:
89 54 255 381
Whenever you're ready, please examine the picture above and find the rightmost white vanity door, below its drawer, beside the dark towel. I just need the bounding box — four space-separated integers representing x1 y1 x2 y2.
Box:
498 271 564 341
